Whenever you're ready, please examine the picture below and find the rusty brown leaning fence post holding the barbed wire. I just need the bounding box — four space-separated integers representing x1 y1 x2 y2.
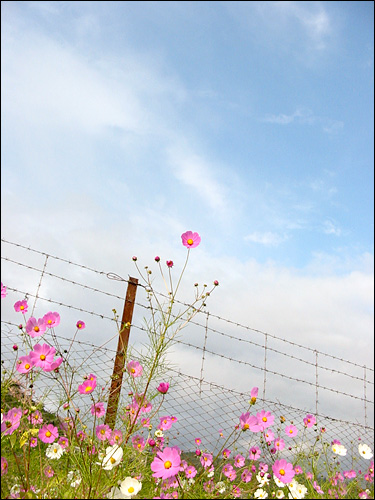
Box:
105 277 138 429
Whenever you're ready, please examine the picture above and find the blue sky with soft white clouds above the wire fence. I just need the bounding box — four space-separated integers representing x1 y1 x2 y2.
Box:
1 1 374 434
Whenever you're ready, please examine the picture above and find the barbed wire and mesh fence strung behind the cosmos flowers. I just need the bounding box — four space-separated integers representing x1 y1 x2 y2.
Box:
2 239 374 460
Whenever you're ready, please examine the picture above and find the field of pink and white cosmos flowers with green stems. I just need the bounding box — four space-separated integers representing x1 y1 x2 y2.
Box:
1 231 374 498
